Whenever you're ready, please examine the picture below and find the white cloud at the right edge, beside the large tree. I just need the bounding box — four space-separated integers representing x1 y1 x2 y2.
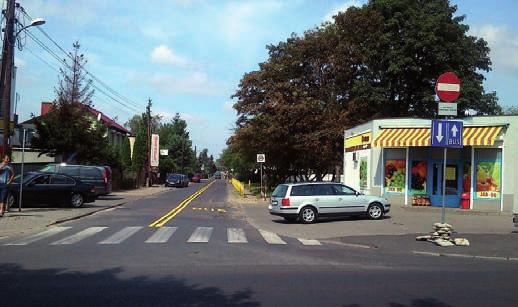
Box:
470 25 518 72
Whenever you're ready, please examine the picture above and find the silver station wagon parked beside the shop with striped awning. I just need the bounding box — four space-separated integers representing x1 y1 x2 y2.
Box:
269 182 390 224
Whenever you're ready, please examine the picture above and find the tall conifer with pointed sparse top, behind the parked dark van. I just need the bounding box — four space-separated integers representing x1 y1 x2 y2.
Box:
32 42 110 163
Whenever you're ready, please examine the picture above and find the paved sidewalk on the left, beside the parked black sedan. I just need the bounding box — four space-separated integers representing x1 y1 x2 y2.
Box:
0 186 170 240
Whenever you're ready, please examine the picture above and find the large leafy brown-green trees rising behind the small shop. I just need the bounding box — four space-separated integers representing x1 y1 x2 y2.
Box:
220 0 501 185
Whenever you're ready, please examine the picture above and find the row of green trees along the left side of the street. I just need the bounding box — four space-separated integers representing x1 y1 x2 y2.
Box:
32 42 216 187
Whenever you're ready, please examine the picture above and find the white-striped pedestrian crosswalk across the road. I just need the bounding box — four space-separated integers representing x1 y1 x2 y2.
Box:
4 226 322 246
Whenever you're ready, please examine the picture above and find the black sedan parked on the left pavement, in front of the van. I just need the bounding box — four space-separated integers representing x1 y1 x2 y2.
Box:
7 172 96 208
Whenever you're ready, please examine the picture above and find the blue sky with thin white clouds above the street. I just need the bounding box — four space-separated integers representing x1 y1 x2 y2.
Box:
10 0 518 157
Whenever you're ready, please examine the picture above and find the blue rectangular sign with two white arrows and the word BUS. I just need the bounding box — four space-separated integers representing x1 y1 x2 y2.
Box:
431 119 464 148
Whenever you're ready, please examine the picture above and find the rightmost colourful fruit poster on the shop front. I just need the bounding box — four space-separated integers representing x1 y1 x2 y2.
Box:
476 162 502 198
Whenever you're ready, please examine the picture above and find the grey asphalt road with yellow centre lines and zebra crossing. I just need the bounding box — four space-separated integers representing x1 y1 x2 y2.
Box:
0 180 518 306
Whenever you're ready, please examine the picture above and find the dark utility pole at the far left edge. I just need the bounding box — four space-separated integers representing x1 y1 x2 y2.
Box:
0 0 16 158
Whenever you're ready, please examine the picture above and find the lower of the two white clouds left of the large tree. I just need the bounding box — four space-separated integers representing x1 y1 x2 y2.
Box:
147 72 225 95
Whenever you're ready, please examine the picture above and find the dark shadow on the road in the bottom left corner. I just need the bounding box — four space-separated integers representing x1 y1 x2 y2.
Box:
0 264 260 307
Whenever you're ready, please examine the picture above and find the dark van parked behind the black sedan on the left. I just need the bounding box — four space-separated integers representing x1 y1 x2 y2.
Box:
40 163 112 195
